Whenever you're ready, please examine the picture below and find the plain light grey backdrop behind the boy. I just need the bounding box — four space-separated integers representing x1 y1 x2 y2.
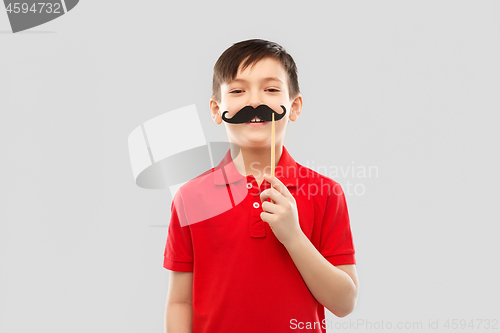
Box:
0 1 500 333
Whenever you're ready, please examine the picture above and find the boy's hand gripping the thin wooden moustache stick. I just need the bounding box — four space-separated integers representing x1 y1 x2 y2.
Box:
260 174 302 246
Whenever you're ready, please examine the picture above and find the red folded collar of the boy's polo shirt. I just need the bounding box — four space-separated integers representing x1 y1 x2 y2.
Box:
214 146 299 187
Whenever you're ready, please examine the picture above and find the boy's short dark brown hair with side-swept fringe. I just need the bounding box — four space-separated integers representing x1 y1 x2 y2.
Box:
212 39 300 102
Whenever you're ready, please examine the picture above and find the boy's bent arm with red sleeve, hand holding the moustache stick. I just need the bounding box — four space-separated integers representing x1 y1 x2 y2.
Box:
260 174 358 317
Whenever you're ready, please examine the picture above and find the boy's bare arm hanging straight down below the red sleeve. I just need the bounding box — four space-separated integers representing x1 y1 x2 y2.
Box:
165 271 193 333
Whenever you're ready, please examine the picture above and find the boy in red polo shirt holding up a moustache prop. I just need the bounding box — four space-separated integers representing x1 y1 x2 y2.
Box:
163 39 358 333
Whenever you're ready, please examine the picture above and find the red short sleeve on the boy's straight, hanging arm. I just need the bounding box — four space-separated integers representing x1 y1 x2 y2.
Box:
163 189 193 272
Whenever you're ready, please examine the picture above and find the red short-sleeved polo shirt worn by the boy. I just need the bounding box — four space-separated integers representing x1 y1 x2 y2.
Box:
163 146 356 333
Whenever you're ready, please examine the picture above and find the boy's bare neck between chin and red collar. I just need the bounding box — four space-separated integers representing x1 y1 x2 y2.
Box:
231 143 283 186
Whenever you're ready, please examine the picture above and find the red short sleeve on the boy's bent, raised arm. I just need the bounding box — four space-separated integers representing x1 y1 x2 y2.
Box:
319 181 356 266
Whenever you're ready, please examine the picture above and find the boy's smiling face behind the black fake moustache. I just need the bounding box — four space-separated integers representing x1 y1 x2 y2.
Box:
210 58 302 148
